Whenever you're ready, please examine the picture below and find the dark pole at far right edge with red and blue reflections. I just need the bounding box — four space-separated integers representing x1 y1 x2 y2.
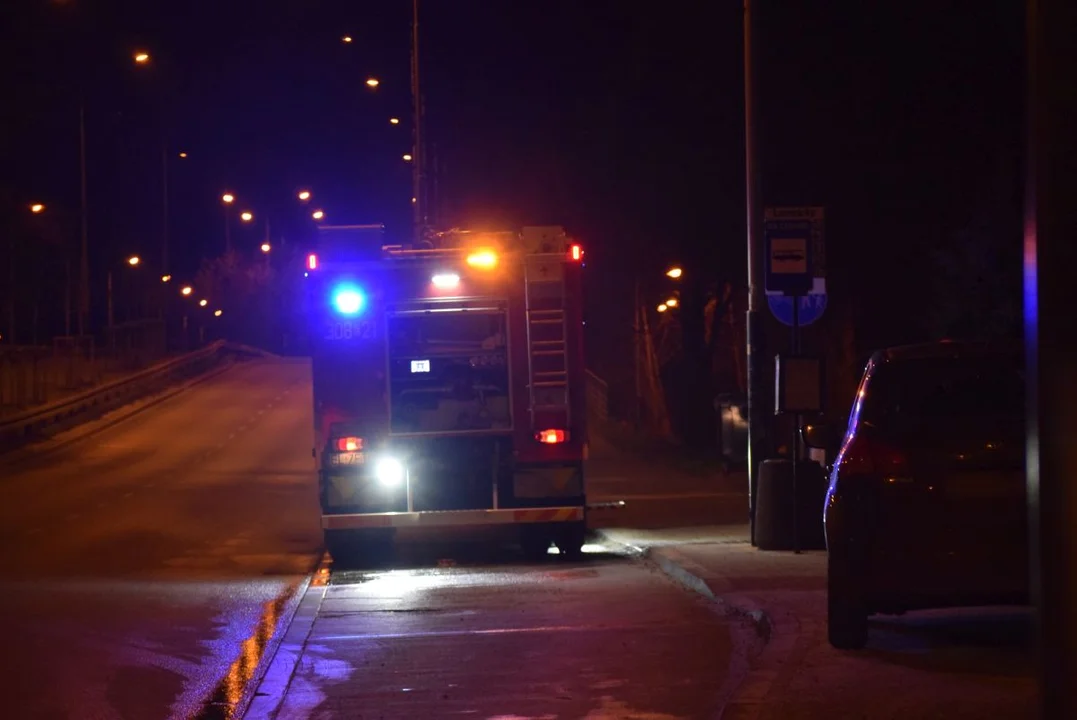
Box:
1024 0 1077 719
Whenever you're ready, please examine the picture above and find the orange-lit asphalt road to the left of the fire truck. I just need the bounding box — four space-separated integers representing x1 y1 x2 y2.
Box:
0 361 321 720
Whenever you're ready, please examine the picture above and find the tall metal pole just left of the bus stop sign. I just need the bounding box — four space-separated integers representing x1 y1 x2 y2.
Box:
744 0 769 545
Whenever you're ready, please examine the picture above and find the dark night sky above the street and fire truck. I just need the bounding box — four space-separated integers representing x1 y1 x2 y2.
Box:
0 0 1023 365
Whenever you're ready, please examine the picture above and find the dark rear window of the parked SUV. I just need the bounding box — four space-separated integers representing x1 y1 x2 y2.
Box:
861 355 1024 424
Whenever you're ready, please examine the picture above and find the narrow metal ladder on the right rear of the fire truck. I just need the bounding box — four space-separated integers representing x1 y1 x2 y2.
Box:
524 255 572 429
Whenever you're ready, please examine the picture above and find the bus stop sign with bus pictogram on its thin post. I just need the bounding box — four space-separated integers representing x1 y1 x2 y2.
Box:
762 207 826 552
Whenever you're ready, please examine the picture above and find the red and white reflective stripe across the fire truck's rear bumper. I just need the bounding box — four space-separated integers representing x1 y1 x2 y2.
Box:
322 507 584 530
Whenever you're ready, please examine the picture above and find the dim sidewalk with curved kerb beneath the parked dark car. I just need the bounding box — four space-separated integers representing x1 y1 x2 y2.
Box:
601 525 1036 720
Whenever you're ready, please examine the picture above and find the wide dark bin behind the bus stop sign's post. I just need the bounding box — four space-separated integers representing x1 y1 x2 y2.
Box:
755 460 827 550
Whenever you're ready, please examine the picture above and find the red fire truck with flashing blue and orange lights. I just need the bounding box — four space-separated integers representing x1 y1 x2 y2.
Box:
306 226 588 559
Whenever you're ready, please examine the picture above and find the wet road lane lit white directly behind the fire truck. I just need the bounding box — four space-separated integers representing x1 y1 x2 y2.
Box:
254 543 731 720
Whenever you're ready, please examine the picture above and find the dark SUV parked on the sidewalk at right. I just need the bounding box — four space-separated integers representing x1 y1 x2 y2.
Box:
803 342 1029 649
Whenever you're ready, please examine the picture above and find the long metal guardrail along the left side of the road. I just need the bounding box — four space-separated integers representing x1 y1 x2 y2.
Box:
0 340 225 452
